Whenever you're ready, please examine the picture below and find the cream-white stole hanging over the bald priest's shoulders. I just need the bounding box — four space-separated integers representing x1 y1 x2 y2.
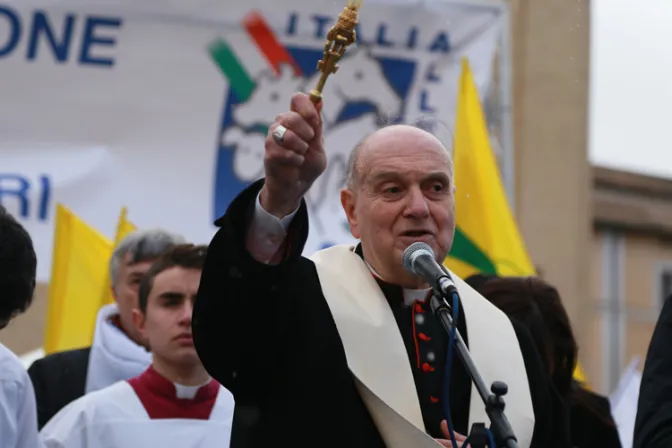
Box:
310 245 534 448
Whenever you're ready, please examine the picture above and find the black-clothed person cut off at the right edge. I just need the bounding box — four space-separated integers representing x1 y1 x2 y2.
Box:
633 295 672 448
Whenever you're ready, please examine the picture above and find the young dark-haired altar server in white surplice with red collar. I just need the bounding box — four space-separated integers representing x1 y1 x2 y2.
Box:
40 245 234 448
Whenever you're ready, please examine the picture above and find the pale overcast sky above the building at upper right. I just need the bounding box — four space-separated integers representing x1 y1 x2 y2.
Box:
592 0 672 178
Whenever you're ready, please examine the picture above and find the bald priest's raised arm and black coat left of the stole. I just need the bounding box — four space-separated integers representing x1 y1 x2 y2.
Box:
193 95 384 448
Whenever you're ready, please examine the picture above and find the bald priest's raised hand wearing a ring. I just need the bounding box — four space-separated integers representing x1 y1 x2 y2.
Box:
260 93 327 218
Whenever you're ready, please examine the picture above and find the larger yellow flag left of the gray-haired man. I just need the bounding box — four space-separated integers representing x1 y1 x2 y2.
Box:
44 204 112 354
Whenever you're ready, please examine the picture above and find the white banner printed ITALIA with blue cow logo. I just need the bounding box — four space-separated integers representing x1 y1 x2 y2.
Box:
0 0 503 281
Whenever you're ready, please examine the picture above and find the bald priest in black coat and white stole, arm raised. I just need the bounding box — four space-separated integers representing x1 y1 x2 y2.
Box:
193 94 570 448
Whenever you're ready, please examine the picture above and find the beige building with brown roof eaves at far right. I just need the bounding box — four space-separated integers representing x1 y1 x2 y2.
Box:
583 168 672 391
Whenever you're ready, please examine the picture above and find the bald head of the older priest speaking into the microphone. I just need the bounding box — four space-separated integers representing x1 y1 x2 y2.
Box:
341 125 455 288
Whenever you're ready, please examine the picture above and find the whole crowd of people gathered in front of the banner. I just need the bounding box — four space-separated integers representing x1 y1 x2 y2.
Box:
0 94 672 448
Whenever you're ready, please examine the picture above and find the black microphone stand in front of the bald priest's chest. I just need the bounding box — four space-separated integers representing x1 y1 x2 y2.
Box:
430 288 518 448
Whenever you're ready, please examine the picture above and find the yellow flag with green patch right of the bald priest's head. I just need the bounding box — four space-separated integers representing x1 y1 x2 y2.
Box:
445 59 584 381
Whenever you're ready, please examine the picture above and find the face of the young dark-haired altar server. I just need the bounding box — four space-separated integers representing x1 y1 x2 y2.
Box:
136 267 201 367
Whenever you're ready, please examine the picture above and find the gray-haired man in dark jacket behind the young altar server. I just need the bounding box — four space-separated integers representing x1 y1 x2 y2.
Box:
28 229 185 428
